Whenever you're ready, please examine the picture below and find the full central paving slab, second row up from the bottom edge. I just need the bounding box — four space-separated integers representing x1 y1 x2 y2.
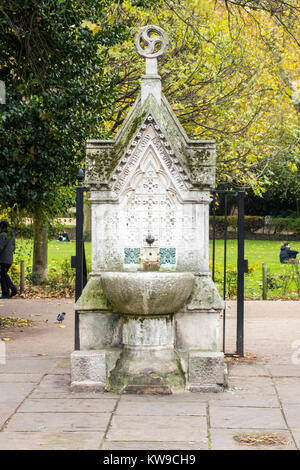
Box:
107 415 207 443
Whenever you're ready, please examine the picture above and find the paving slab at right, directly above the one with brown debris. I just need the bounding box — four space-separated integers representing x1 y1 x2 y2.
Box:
210 406 286 429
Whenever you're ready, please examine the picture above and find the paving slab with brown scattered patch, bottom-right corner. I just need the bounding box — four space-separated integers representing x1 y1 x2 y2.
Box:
210 427 296 450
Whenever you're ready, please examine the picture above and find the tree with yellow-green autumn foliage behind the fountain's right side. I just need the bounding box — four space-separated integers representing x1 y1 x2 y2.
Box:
105 0 298 193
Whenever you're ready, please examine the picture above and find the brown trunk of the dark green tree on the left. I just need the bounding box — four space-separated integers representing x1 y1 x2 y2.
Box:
32 213 48 285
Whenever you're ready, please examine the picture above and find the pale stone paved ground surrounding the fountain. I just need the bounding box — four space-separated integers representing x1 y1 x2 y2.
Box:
0 300 300 450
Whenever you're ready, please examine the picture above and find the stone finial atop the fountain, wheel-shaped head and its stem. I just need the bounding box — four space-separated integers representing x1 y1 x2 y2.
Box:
135 25 169 104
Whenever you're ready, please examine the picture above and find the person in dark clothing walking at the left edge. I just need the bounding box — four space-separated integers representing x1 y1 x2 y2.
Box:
0 220 18 299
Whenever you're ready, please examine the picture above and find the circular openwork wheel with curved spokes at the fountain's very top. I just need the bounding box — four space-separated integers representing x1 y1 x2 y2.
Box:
135 25 169 59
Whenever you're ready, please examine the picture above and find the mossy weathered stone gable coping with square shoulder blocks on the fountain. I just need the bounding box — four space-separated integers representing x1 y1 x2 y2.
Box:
86 93 216 188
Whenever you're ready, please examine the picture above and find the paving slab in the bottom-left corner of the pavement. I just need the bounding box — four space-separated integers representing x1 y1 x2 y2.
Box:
0 431 104 450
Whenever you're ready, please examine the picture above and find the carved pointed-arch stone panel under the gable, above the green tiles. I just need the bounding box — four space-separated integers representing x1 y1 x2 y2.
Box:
111 119 188 250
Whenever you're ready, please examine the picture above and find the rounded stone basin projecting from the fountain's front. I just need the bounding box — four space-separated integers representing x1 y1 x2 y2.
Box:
101 272 194 315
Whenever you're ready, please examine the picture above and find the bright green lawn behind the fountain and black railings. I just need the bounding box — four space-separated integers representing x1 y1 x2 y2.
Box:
11 240 300 299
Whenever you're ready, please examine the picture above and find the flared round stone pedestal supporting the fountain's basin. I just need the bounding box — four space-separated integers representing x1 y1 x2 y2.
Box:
108 315 185 394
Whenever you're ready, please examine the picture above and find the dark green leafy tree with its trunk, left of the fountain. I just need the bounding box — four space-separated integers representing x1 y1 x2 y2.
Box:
0 0 135 283
